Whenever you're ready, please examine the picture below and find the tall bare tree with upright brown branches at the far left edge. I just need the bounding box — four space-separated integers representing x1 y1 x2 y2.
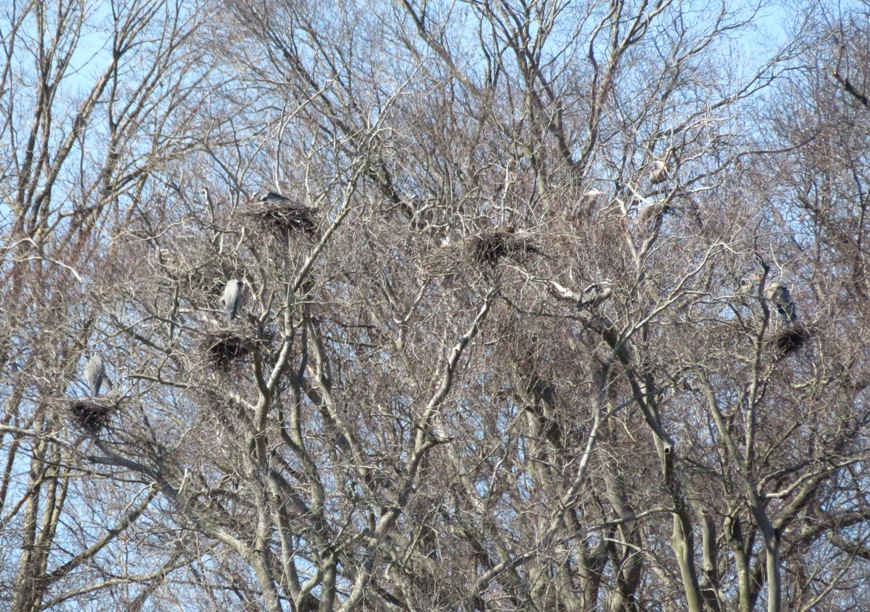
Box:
0 0 225 610
